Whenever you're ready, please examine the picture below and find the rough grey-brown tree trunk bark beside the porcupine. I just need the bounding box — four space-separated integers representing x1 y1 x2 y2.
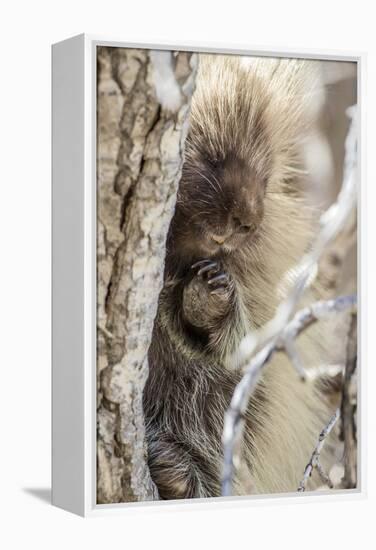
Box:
97 47 196 503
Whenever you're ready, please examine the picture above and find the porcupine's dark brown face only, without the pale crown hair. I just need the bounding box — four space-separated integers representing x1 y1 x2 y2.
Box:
167 146 266 257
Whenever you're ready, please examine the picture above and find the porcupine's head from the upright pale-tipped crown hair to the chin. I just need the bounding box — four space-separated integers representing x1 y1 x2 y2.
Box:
166 59 278 264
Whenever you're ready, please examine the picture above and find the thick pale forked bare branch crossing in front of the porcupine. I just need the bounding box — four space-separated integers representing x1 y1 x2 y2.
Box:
222 106 357 495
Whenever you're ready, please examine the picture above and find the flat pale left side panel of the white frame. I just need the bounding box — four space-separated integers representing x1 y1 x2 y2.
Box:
52 33 85 514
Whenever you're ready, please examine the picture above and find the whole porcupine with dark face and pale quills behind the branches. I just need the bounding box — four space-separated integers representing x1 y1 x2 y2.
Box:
143 55 332 499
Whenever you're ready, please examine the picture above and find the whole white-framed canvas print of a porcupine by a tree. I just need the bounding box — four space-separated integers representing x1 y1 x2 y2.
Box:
52 35 364 515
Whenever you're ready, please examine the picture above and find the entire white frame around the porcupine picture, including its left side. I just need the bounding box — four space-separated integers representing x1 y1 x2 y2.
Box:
52 34 366 516
